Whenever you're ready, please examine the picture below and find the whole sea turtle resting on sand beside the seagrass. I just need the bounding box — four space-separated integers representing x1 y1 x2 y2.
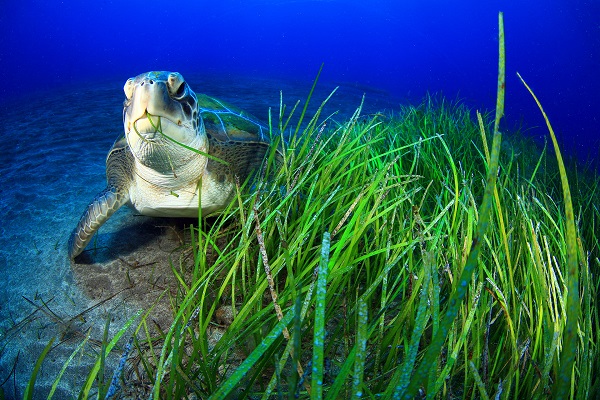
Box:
68 71 270 259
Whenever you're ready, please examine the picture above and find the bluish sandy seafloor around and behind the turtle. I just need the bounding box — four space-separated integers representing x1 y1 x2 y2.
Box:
0 71 398 399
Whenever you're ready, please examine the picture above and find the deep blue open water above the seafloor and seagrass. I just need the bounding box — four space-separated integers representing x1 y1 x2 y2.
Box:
0 0 600 165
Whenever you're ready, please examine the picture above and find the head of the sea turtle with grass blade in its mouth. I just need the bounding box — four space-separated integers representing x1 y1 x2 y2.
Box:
123 71 207 170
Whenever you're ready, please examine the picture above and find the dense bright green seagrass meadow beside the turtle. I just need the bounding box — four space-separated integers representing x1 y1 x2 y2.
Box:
25 14 600 399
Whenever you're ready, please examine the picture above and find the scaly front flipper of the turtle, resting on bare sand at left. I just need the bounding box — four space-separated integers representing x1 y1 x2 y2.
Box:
69 186 129 259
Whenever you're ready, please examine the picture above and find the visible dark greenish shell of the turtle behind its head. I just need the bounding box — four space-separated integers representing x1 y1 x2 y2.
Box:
196 94 270 144
